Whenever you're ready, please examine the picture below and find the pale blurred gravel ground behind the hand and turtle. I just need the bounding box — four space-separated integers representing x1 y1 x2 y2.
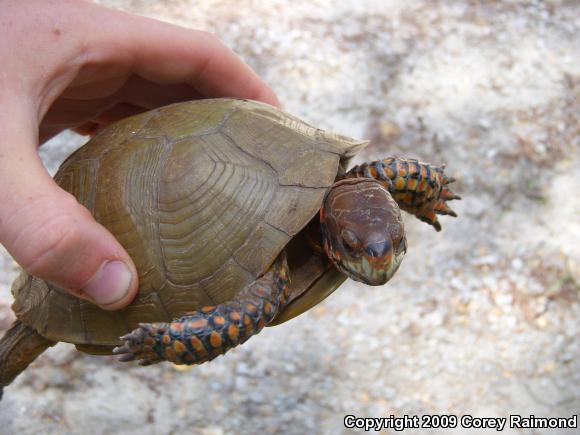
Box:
0 0 580 435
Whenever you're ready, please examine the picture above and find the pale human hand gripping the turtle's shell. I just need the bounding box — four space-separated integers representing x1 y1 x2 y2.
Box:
0 0 279 310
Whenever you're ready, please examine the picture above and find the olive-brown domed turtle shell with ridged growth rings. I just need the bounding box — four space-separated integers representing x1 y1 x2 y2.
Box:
13 99 366 351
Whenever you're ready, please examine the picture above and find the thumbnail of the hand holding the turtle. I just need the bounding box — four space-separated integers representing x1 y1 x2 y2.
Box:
82 260 133 305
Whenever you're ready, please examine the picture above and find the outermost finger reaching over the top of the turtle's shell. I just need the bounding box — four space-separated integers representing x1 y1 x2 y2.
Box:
88 5 280 106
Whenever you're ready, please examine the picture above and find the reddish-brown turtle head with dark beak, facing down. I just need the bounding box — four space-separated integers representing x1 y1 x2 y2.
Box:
320 178 407 285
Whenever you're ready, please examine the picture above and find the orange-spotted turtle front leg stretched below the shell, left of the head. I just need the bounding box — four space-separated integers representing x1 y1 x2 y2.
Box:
113 254 289 365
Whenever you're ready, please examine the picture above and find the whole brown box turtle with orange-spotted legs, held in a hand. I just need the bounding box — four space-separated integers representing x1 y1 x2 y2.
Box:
0 98 459 398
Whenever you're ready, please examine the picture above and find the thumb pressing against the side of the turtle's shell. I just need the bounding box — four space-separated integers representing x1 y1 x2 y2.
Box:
0 112 137 310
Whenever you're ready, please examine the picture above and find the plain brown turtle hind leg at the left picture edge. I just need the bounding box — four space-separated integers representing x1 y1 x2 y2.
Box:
0 320 56 399
